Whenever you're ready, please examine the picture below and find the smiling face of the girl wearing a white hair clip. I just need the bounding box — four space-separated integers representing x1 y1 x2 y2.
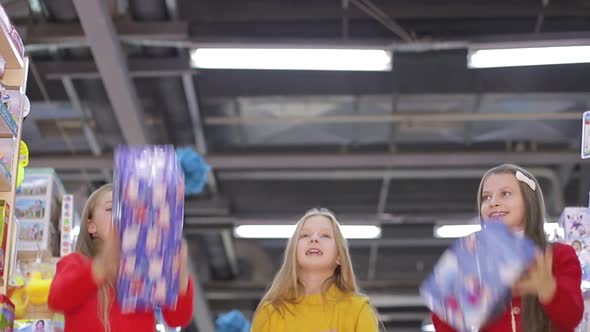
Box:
480 173 526 230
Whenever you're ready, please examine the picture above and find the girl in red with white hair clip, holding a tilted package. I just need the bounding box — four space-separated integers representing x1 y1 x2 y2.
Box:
432 164 584 332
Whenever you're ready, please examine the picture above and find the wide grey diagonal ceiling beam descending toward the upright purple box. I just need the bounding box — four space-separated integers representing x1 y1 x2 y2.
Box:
74 0 149 145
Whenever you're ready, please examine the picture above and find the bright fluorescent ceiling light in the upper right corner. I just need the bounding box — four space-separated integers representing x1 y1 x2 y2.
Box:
467 46 590 68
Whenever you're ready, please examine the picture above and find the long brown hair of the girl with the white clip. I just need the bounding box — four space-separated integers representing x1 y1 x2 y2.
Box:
477 164 552 332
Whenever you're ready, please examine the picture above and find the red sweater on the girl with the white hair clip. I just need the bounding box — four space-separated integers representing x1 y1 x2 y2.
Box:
432 243 584 332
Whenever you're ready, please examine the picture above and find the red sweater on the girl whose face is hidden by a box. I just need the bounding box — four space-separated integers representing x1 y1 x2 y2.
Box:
48 253 194 332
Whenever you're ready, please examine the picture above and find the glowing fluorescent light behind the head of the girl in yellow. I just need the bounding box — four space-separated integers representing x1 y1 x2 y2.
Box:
234 225 381 239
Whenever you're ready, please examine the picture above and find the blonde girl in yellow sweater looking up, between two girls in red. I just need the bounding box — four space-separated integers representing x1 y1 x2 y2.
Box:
251 209 378 332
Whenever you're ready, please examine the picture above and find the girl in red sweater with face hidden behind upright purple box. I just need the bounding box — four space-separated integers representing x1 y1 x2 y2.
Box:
48 184 194 332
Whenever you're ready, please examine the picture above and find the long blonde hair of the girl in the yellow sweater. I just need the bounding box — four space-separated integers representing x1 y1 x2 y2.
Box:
257 208 359 314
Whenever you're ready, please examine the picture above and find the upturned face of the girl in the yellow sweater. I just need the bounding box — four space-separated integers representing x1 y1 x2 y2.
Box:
297 215 338 271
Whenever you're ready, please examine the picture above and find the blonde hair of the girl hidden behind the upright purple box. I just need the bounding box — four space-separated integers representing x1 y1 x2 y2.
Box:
76 184 113 331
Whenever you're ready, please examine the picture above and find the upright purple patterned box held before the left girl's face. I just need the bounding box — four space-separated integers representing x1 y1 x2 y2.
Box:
113 146 184 313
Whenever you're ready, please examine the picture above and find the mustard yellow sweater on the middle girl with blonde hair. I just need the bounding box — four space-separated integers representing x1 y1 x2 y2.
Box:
251 285 378 332
